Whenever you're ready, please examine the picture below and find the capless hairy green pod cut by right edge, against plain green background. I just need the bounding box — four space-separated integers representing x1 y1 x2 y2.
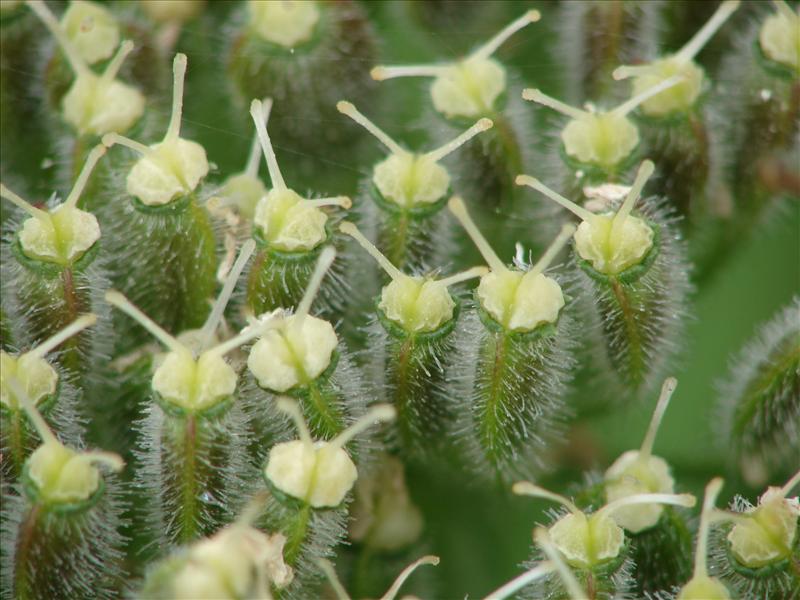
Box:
714 297 800 485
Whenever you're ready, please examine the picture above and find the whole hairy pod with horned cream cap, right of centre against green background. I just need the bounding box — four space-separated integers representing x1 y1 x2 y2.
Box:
517 161 692 402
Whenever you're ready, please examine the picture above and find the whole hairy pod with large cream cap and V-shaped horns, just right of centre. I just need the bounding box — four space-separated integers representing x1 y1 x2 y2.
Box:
448 197 577 479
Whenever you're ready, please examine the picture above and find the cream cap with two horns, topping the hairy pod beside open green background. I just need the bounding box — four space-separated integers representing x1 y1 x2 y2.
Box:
517 160 654 275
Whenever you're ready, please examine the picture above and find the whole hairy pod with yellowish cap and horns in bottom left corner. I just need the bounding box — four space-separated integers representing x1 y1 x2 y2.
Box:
0 376 127 600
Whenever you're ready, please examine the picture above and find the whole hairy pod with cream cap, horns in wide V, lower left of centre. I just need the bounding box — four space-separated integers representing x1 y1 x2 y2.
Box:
106 255 264 545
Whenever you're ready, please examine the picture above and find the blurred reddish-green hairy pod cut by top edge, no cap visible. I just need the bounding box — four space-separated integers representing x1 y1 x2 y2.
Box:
558 0 659 103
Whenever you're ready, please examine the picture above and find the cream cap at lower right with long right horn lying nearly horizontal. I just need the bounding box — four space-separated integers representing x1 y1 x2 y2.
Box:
512 481 695 570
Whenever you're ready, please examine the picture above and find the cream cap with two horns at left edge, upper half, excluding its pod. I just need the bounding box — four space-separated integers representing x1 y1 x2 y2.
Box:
0 146 106 267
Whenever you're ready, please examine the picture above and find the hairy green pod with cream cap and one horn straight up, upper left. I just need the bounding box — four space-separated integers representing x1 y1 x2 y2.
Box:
103 54 217 350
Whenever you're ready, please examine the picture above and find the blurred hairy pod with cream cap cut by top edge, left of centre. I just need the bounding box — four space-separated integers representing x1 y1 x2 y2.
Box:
227 1 376 162
